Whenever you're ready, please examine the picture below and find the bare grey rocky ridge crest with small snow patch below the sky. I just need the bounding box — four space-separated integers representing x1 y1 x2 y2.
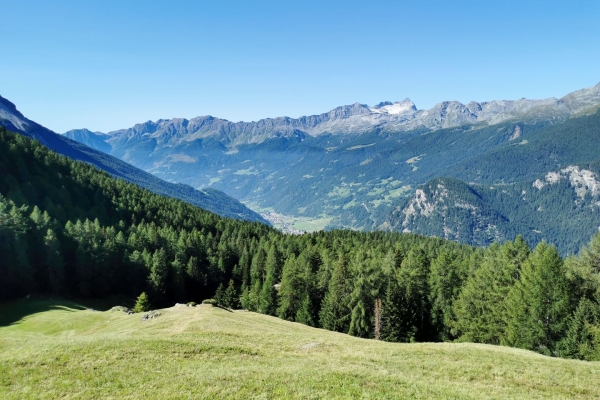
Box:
70 83 600 151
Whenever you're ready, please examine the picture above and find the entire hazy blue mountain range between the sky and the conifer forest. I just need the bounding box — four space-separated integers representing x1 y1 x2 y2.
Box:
0 84 600 253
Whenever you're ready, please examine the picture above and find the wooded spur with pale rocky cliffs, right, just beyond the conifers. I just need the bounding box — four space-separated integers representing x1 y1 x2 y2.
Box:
387 170 600 254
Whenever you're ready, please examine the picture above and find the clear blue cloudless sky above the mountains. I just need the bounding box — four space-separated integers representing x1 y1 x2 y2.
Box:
0 0 600 132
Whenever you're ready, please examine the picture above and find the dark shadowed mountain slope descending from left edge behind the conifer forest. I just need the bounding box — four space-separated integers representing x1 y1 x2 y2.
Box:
0 97 266 223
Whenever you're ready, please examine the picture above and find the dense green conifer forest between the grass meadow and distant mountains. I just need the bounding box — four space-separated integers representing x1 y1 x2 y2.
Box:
5 129 600 360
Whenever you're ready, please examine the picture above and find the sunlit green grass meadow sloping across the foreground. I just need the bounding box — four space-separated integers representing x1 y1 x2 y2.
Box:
0 299 600 399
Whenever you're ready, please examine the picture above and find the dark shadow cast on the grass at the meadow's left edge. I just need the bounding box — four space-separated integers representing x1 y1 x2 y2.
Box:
0 295 131 327
